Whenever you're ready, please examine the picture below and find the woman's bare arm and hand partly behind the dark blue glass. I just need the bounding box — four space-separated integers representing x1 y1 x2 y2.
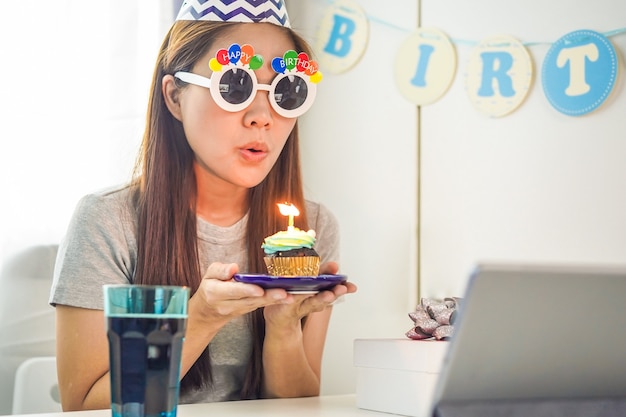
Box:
56 263 287 411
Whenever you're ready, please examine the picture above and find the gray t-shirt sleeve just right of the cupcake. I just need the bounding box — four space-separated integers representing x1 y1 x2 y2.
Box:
307 202 339 263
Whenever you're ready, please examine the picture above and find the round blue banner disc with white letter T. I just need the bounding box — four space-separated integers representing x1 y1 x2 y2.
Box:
541 30 619 116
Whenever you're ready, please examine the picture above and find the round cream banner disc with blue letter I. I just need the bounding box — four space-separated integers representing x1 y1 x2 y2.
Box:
394 28 456 106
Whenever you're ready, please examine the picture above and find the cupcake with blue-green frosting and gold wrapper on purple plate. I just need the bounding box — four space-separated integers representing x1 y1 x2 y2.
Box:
261 226 320 277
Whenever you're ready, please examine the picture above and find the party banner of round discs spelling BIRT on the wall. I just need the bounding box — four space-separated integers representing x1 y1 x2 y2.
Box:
316 0 626 117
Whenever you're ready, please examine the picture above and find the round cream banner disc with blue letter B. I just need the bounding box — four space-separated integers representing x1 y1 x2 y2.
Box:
315 0 369 74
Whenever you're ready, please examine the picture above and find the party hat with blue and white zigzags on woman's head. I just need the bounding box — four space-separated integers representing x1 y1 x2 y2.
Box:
176 0 291 27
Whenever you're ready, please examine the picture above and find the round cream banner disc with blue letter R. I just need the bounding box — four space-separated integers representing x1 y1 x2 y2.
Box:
465 35 533 117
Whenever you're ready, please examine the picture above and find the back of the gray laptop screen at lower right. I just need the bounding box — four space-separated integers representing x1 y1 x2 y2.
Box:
433 264 626 412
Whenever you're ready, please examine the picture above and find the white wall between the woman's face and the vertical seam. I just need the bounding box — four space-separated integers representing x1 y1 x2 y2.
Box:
288 0 418 394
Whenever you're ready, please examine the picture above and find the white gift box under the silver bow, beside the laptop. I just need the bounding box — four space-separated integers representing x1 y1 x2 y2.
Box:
354 338 448 417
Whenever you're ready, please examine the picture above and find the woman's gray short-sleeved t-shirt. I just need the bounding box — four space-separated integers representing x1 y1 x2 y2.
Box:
49 187 339 403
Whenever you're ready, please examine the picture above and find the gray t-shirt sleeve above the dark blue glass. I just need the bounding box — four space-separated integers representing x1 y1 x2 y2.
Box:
49 191 137 309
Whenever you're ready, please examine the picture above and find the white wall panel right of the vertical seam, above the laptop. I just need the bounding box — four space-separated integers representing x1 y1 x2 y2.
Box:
420 0 626 297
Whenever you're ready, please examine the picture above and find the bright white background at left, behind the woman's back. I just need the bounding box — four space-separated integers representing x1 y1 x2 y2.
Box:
0 0 172 415
